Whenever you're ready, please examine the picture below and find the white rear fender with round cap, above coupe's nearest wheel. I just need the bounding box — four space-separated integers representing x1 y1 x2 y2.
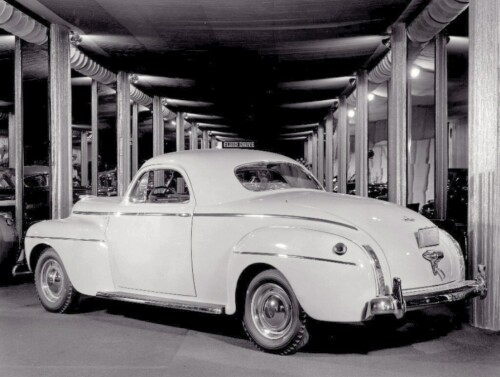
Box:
226 227 376 322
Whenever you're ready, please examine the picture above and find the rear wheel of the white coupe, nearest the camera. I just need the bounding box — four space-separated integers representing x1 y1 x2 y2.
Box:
243 270 309 355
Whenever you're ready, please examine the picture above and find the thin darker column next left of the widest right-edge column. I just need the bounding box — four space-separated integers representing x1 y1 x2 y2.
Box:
434 32 448 219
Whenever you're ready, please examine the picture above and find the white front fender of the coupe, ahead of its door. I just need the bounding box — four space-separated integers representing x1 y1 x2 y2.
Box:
25 215 113 295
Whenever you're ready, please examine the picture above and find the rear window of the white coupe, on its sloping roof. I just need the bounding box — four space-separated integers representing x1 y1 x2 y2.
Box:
235 162 323 191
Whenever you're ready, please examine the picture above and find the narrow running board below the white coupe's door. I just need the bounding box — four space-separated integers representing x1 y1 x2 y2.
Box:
96 292 224 314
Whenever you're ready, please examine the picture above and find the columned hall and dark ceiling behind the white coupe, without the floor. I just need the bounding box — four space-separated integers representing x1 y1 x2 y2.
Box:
0 0 500 374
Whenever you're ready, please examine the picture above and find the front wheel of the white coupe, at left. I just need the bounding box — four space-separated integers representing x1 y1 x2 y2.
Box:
35 248 79 313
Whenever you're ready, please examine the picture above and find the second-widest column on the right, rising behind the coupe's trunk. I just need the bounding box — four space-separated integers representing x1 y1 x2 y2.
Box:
387 23 408 206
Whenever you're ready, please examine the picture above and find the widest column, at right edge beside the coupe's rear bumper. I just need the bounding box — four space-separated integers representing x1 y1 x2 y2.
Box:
468 0 500 331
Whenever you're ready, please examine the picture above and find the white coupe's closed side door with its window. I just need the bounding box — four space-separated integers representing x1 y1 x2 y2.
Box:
106 167 196 296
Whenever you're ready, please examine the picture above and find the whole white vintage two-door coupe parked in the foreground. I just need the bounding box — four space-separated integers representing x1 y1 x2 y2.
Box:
25 150 486 354
